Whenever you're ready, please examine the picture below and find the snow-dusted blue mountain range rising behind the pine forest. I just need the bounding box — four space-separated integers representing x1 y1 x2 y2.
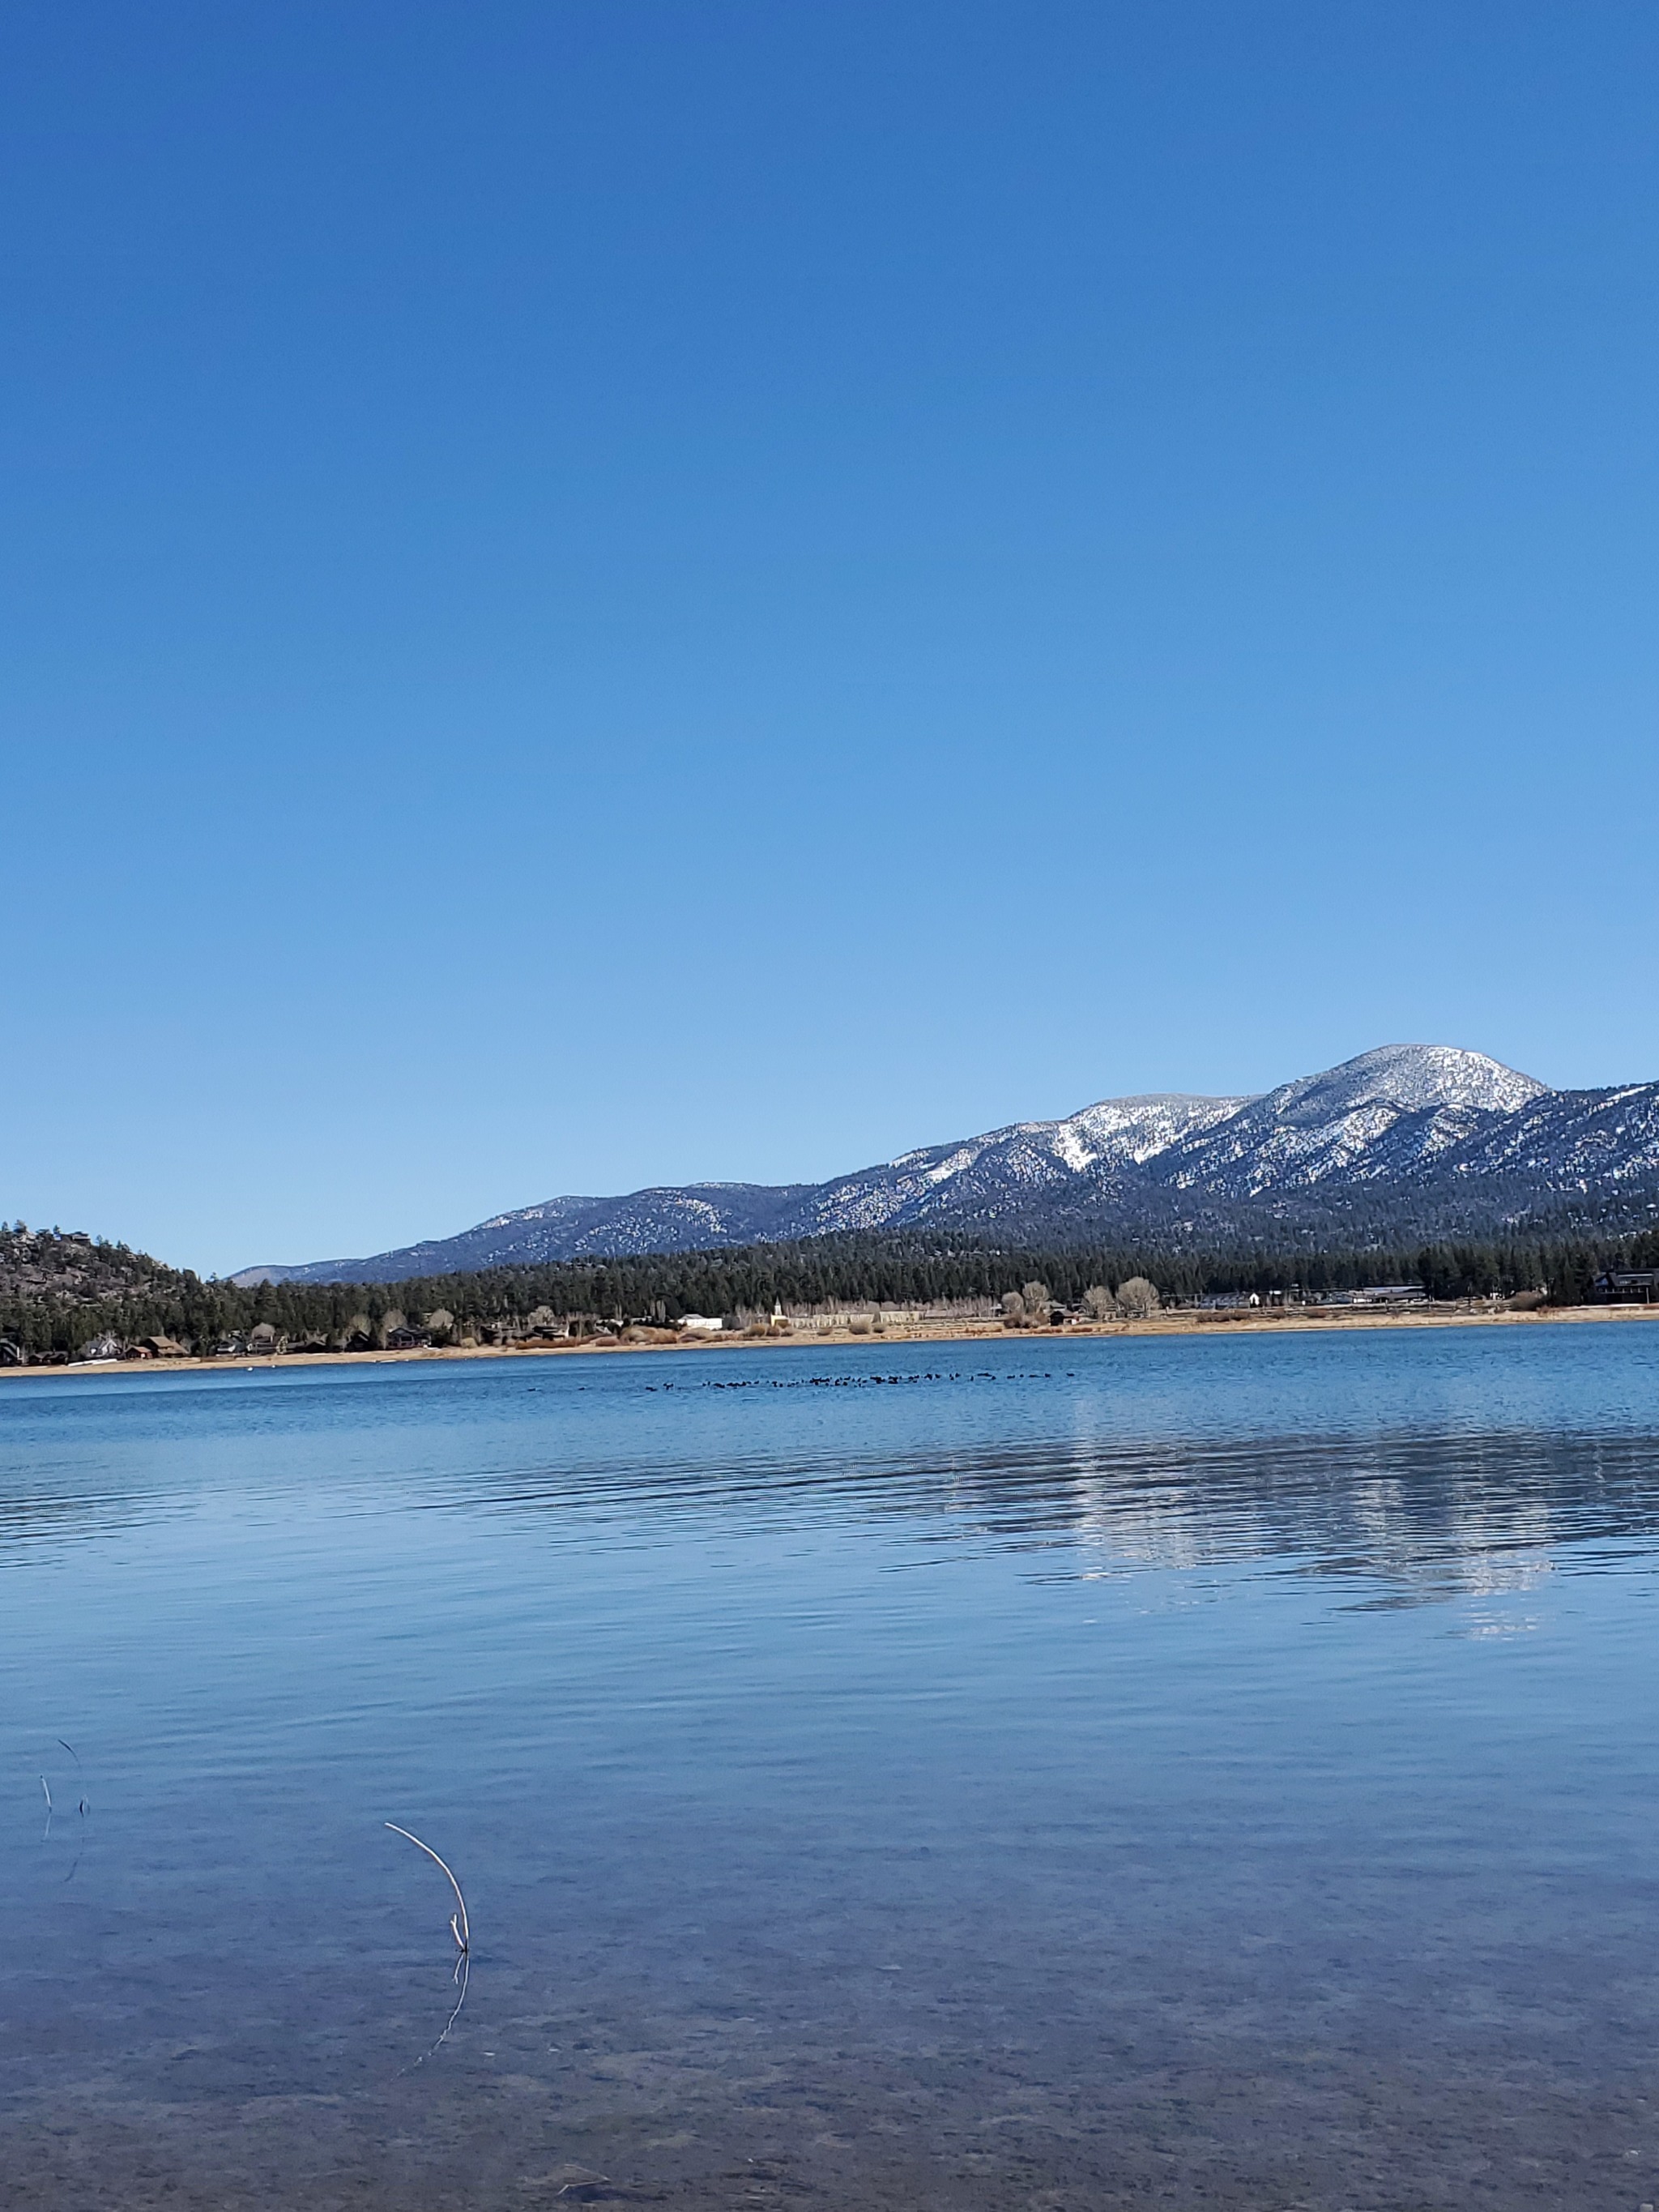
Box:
237 1044 1659 1283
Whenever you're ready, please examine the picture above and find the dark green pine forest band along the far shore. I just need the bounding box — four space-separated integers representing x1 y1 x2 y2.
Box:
0 1223 1659 1360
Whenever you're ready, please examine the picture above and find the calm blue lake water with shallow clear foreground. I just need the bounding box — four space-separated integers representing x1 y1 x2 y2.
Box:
0 1325 1659 2212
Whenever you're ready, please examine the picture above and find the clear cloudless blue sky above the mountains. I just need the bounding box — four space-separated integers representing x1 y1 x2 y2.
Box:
0 0 1659 1270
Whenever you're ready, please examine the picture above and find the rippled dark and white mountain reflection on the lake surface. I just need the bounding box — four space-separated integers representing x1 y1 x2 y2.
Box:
395 1429 1659 1603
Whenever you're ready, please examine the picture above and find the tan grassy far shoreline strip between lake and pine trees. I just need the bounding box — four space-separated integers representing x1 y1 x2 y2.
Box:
0 1305 1659 1382
